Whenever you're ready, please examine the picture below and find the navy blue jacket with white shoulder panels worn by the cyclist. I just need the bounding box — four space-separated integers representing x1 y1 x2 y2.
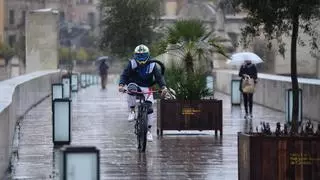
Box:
119 59 166 87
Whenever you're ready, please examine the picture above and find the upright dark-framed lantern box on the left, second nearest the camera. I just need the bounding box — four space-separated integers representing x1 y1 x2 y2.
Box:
52 99 71 146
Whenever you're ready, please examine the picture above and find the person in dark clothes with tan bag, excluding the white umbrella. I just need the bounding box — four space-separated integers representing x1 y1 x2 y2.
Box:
239 60 258 118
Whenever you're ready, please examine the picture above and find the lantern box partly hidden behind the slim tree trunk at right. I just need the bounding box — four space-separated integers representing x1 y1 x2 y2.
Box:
285 88 303 124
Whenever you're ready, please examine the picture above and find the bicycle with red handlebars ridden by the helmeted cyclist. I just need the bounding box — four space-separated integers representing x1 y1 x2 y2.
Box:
124 85 175 152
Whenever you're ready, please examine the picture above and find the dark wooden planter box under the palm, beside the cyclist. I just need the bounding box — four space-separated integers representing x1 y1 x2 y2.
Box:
157 99 223 136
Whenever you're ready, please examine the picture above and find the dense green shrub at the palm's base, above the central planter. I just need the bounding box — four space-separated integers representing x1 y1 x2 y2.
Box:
165 61 213 100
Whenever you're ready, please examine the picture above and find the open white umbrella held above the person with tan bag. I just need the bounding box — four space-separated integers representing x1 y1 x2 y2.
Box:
227 52 263 65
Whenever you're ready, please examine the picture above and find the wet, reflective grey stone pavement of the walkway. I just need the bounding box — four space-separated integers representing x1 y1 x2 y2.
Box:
13 74 284 180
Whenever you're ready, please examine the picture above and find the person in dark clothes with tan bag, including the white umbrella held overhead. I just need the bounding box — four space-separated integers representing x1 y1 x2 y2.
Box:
228 52 263 119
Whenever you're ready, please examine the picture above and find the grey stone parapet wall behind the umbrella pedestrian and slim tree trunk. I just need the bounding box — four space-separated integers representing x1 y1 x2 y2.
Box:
213 70 320 122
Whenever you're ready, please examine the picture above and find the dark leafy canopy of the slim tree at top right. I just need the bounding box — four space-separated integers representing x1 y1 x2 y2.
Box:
229 0 320 55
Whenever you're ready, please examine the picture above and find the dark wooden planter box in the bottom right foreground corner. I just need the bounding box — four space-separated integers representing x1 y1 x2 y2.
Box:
238 133 320 180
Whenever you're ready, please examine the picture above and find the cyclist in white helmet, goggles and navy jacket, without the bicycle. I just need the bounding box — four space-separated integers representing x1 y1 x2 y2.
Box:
119 44 168 141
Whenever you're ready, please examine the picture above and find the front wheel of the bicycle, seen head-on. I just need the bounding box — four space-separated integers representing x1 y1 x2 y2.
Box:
137 105 148 152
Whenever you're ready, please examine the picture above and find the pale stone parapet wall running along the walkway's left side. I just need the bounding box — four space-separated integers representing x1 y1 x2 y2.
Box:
0 70 61 179
